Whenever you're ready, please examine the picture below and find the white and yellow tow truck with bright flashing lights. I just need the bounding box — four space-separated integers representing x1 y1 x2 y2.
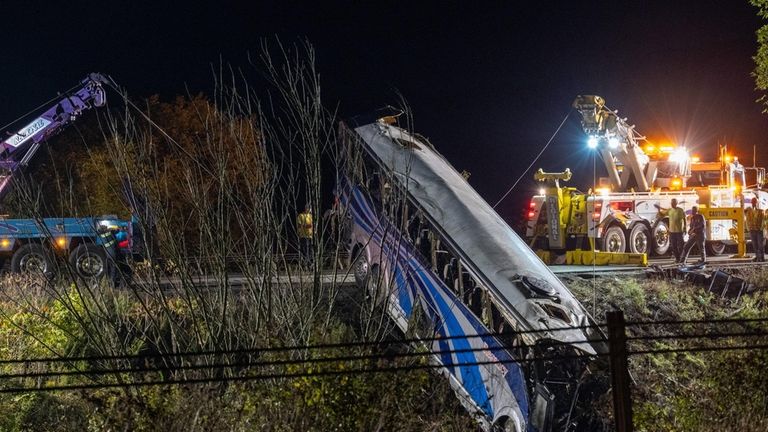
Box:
526 95 768 256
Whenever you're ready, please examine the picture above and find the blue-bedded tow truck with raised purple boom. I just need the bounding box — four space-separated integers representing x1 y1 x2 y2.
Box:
0 73 134 279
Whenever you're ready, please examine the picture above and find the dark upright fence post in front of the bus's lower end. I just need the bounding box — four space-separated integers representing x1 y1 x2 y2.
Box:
605 310 633 432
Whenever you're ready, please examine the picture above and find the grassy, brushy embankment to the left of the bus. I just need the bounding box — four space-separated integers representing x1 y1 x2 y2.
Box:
0 276 474 431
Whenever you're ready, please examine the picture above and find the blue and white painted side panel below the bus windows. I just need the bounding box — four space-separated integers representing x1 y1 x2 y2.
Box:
342 184 528 430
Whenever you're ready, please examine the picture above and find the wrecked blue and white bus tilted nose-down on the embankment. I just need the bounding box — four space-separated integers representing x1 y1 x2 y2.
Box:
338 117 607 431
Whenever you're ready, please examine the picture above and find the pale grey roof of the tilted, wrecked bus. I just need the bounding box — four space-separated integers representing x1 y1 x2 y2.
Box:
354 122 594 353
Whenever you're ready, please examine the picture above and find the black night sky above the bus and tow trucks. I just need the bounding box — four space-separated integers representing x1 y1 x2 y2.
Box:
0 0 768 220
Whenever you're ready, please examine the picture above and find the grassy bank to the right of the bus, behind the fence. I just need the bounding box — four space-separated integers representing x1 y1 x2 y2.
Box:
568 268 768 431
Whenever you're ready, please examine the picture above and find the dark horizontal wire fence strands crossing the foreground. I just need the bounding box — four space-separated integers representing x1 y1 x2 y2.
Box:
0 318 768 393
